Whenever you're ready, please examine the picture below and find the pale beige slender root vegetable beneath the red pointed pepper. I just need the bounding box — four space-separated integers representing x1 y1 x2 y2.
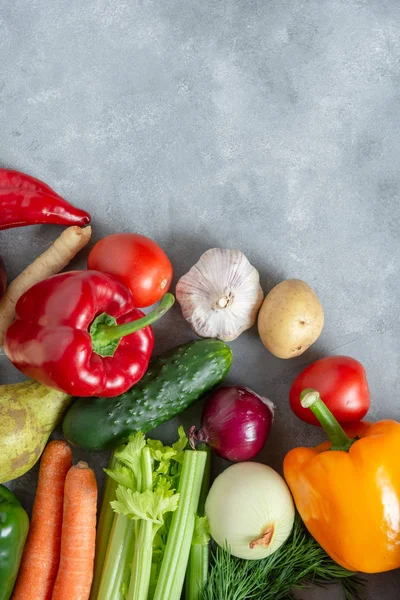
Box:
0 225 92 347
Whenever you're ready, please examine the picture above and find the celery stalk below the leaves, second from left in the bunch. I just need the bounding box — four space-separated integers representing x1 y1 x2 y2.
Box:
96 514 135 600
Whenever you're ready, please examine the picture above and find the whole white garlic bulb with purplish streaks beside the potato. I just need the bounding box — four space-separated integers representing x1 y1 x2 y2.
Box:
176 248 264 342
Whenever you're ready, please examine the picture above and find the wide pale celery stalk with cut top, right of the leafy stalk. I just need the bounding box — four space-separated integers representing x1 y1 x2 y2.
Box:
154 450 207 600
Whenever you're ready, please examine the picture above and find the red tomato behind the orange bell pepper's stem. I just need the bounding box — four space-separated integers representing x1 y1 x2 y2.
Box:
289 356 370 425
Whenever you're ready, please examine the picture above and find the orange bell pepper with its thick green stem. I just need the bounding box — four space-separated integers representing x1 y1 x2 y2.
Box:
283 389 400 573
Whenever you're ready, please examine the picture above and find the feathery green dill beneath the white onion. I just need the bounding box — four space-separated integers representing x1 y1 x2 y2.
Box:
202 515 363 600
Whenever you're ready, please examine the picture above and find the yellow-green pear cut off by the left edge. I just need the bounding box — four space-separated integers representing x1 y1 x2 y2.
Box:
0 379 72 483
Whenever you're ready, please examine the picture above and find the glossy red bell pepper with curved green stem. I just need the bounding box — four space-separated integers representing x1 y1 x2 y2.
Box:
4 271 174 396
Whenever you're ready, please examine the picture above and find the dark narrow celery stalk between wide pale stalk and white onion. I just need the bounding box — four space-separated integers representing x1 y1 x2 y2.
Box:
185 444 211 600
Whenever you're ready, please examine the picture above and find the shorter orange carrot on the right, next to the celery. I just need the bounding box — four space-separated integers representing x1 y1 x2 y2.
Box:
52 461 97 600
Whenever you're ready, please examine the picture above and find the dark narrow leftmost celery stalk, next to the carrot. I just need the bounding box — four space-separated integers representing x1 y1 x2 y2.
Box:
90 453 117 600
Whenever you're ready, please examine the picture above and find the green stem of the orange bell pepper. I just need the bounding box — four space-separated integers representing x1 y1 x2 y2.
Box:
300 388 356 452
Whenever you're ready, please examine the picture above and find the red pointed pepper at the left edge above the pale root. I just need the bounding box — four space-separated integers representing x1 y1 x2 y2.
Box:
0 169 90 230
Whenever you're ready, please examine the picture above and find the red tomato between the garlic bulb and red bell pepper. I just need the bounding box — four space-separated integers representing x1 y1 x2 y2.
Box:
88 233 173 308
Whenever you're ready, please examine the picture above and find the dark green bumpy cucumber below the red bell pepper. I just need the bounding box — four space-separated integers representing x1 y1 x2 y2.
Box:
63 339 232 450
